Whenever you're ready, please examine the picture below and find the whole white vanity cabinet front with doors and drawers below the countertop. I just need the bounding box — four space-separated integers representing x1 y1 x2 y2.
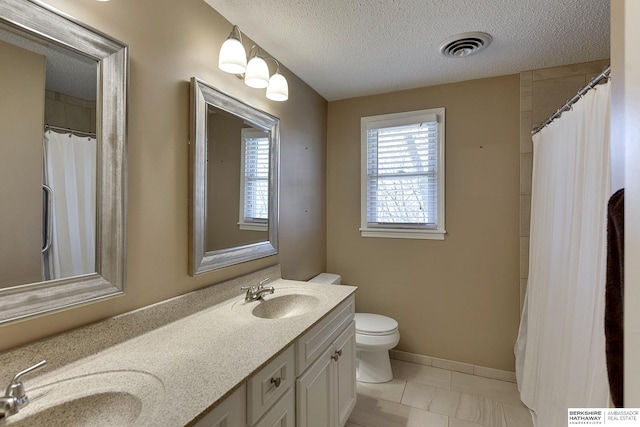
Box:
195 295 356 427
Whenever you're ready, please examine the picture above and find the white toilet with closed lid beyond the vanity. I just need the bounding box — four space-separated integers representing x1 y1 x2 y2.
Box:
309 273 400 383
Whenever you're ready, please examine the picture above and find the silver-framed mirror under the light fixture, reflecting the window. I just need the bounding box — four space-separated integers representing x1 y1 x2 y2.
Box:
189 77 280 275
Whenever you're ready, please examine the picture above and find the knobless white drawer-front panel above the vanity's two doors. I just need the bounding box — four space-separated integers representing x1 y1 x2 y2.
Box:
295 295 355 376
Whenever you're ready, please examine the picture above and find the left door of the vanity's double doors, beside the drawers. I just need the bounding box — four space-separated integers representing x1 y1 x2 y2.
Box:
296 346 336 427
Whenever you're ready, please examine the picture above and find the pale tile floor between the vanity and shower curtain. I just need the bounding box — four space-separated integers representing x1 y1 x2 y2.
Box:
345 359 533 427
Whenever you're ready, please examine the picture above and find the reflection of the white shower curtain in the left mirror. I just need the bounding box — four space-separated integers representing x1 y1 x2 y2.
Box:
43 130 97 280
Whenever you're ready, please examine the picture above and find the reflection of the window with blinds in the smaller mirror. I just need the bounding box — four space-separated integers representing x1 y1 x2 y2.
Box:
239 128 269 231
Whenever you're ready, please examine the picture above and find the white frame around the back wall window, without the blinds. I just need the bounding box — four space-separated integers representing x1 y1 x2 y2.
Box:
360 107 446 240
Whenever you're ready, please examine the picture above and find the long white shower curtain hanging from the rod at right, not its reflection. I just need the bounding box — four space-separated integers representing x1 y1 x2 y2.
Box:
515 83 611 427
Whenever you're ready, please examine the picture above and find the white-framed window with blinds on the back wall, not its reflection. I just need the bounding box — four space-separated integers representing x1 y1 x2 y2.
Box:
361 108 445 239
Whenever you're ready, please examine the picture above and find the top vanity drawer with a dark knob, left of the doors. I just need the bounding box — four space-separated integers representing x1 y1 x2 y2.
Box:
247 346 295 425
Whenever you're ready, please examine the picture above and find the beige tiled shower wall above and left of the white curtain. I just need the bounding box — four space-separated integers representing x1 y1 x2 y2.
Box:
520 59 609 311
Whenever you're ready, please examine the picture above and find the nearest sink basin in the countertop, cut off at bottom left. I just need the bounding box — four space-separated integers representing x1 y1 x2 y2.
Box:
5 371 165 427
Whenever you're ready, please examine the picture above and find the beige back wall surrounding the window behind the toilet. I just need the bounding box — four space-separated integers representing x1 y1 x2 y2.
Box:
327 75 519 371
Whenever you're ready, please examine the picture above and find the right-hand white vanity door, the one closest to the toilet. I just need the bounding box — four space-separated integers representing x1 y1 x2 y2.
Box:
334 321 356 427
